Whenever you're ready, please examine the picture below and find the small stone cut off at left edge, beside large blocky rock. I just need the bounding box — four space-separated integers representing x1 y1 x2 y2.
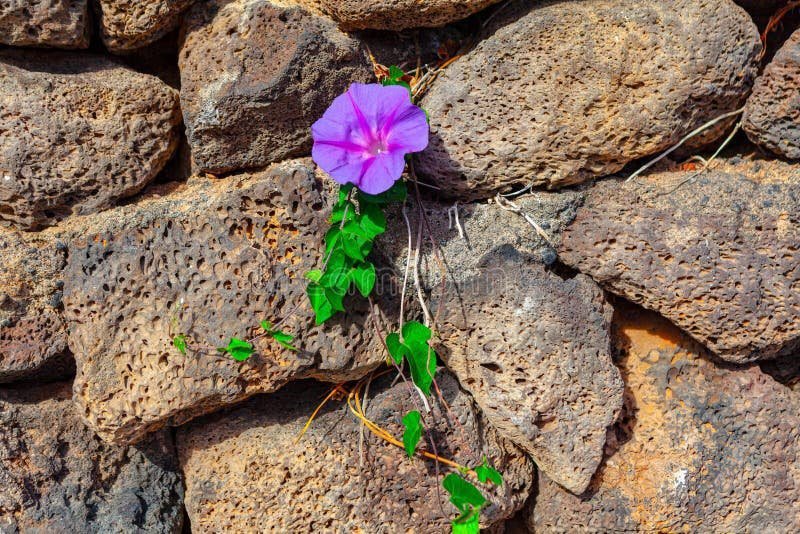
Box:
0 228 74 384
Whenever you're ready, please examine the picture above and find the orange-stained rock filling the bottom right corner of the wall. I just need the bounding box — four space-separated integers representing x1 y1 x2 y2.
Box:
529 311 800 532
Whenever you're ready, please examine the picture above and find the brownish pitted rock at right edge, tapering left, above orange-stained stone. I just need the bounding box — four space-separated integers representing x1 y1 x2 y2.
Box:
559 161 800 362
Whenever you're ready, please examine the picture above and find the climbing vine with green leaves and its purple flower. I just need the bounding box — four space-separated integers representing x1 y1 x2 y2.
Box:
173 66 503 534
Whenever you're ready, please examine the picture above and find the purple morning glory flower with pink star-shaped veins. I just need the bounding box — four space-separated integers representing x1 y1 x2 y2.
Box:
311 83 428 195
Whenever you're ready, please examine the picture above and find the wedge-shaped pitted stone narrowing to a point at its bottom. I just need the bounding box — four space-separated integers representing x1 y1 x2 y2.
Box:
431 253 624 493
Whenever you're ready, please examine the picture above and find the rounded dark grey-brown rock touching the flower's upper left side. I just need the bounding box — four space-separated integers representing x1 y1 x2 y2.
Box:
180 0 374 172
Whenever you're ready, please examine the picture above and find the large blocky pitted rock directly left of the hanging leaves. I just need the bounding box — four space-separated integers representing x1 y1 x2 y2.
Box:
64 160 388 443
